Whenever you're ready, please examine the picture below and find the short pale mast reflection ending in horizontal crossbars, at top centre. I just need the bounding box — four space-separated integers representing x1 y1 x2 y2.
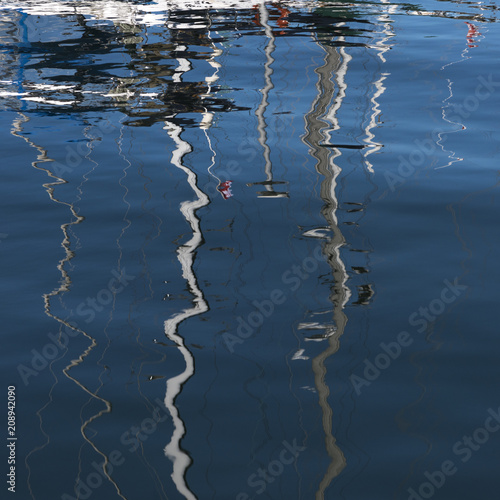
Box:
247 3 288 198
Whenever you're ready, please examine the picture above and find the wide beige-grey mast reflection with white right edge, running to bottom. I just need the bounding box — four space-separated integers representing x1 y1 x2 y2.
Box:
303 33 351 500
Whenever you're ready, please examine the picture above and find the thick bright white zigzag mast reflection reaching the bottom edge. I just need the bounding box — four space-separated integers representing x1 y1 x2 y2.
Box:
164 122 210 500
